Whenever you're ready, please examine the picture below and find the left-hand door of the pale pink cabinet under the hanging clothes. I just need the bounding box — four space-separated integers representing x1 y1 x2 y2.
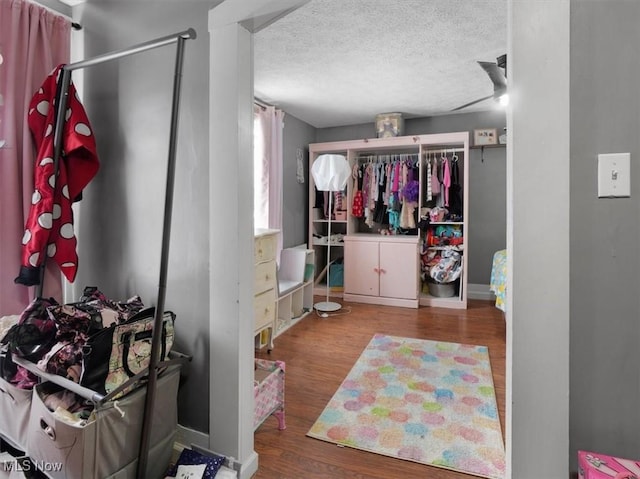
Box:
344 241 380 296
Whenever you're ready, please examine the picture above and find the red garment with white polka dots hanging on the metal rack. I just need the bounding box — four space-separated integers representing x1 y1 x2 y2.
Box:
15 65 99 286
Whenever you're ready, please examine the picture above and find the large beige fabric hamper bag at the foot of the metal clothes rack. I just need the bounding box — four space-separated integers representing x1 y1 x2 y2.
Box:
27 366 180 479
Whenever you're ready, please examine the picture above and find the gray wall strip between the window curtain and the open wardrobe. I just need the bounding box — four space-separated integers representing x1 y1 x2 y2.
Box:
282 114 316 248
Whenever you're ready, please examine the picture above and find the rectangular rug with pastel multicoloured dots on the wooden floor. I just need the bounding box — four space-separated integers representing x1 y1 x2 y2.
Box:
307 334 505 479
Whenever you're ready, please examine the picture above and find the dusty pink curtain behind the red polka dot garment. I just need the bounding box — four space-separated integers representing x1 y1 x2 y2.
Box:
0 0 71 316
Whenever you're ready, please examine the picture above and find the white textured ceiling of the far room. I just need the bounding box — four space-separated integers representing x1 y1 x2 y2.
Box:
254 0 507 128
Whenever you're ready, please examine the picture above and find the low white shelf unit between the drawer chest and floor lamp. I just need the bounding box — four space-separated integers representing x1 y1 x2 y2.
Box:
274 248 315 337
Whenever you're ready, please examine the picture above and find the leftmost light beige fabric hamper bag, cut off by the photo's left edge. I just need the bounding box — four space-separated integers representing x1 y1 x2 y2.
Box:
0 378 32 451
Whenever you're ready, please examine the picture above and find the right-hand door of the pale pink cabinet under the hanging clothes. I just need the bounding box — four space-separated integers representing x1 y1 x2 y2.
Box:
380 243 418 299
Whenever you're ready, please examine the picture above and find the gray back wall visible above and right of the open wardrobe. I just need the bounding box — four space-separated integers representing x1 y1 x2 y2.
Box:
316 110 507 285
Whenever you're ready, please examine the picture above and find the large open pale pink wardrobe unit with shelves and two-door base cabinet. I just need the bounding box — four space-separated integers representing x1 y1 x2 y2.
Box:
309 131 469 308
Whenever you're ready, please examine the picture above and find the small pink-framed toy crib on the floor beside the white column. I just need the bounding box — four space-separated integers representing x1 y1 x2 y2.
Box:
253 359 286 430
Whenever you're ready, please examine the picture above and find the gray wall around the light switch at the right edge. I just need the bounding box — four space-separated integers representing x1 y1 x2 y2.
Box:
570 0 640 469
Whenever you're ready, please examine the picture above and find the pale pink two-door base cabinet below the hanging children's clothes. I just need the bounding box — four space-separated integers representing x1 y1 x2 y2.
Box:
344 235 419 308
